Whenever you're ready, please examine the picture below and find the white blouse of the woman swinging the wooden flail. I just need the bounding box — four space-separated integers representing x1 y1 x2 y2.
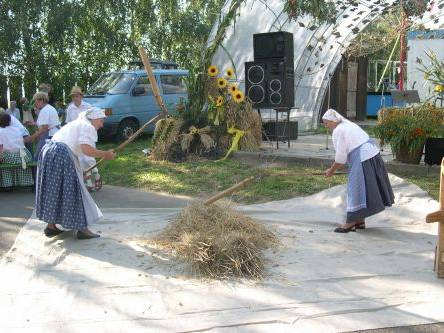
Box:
52 118 97 158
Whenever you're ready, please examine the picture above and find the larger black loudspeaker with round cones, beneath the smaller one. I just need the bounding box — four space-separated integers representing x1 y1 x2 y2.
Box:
245 58 294 109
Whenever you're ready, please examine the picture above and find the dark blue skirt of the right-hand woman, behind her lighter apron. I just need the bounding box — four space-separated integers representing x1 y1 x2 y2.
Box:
347 154 395 222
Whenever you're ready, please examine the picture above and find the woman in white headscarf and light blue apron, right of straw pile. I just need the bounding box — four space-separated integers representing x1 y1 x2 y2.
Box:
322 109 394 233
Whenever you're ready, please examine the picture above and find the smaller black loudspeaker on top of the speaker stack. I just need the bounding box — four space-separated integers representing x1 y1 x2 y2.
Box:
253 31 294 63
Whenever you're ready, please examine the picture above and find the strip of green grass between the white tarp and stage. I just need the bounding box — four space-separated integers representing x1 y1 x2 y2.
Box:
98 136 439 203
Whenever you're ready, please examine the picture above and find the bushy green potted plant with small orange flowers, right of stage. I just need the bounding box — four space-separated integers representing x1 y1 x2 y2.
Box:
375 103 444 164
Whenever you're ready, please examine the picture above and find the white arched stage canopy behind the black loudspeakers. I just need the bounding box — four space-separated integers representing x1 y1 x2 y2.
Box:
208 0 444 130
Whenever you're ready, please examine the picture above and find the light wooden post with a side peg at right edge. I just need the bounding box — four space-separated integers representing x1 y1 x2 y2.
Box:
426 158 444 278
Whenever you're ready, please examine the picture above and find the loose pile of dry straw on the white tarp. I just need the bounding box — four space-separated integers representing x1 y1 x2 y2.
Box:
156 203 278 279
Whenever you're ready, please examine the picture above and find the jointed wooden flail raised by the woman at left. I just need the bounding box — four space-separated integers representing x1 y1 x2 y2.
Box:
83 47 168 173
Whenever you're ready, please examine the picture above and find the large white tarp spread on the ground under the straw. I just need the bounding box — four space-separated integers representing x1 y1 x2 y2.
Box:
0 176 444 333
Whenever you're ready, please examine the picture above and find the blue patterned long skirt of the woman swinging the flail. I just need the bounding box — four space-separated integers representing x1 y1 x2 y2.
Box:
35 141 87 230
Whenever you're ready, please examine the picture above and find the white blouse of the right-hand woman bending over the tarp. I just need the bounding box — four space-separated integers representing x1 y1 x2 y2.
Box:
332 121 379 164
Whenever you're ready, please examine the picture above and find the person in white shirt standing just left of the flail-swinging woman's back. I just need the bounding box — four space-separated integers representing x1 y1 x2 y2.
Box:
33 91 60 160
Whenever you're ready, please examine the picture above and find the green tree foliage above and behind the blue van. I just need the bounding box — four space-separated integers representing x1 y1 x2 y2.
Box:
0 0 398 104
